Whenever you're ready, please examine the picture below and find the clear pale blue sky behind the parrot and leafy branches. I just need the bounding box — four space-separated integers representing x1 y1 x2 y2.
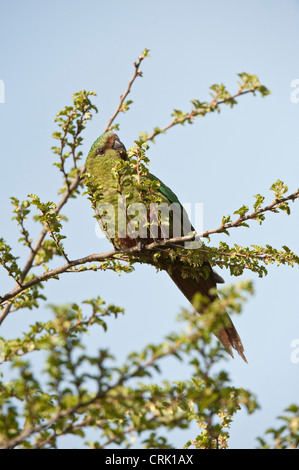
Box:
0 0 299 448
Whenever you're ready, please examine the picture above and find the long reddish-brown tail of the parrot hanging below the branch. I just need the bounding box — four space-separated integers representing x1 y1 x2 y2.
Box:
168 265 247 362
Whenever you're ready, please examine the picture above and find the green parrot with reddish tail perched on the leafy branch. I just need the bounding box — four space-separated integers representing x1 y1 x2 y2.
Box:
86 131 247 362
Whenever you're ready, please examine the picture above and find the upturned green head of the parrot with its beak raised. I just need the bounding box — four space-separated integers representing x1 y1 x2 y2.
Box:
87 131 127 160
